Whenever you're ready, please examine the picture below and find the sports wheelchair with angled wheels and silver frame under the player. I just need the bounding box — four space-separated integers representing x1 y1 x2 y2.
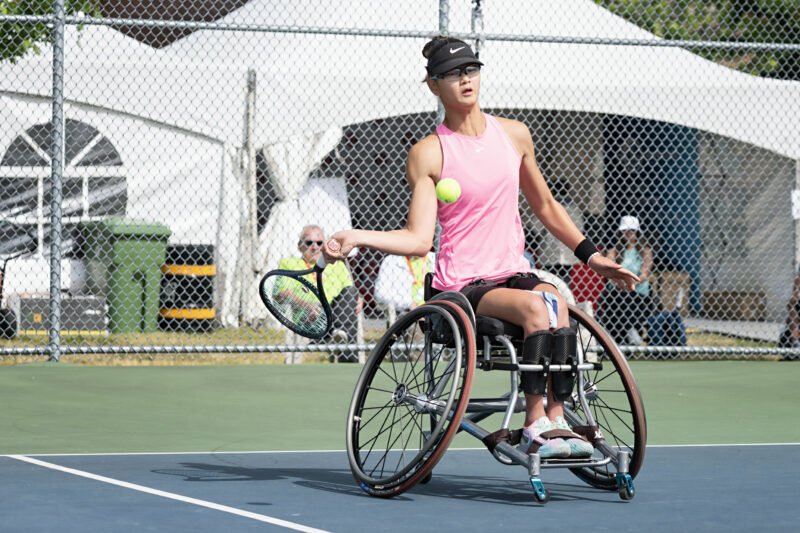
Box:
347 280 647 504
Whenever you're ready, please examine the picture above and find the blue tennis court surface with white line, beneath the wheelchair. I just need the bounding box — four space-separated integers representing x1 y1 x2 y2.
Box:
0 444 800 533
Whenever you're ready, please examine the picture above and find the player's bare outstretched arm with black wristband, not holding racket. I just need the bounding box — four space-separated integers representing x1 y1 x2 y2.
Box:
498 119 639 290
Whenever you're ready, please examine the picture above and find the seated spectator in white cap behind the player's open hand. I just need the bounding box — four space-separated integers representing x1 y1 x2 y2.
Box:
597 216 654 345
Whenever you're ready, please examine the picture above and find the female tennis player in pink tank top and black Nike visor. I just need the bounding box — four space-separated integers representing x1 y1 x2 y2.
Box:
324 37 639 458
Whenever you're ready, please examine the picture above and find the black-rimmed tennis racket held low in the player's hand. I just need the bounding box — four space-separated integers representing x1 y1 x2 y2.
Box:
258 239 339 339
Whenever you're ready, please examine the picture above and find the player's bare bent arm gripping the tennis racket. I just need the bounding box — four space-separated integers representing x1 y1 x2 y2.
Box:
323 135 442 261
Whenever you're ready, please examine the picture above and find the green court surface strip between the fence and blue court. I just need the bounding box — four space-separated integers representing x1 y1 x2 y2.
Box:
0 361 800 454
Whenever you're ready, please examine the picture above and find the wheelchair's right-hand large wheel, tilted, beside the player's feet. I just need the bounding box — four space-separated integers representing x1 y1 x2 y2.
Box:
564 306 647 490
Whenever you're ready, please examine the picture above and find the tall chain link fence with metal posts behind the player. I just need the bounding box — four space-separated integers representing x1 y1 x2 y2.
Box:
0 0 800 363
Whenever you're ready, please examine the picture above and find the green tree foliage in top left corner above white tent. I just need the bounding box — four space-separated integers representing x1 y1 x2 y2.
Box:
0 0 99 63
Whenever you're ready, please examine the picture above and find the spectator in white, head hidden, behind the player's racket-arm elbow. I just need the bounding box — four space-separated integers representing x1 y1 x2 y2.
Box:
375 252 435 312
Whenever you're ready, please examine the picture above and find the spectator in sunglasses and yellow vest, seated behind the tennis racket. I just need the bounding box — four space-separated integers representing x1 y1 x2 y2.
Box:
278 225 362 361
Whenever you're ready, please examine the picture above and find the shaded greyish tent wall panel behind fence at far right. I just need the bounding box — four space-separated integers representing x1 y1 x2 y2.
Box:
698 133 795 320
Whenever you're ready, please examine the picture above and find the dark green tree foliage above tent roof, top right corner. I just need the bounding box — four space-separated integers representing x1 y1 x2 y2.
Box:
595 0 800 80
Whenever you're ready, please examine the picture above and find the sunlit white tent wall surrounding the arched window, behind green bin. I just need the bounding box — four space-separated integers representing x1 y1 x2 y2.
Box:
0 95 245 318
